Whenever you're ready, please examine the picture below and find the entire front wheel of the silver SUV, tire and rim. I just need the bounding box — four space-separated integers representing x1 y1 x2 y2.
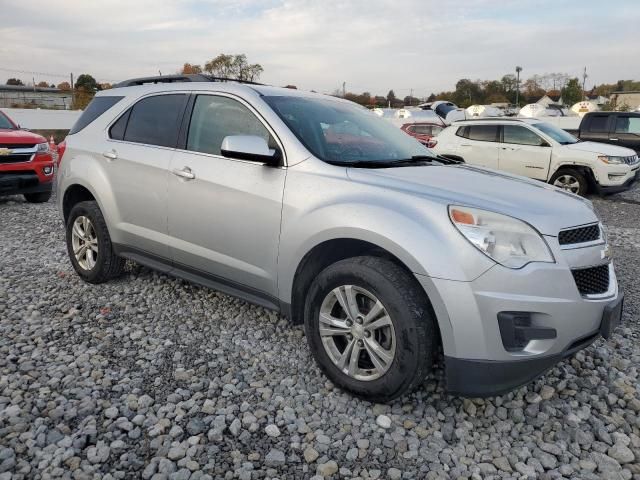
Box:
305 257 437 402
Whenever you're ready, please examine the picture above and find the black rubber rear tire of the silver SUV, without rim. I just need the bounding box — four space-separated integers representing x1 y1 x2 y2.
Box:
66 201 125 283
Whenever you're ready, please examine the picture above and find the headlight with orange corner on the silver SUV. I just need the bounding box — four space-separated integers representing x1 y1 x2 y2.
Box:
449 205 555 268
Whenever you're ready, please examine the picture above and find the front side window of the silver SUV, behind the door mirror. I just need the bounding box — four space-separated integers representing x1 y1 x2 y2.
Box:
187 95 276 155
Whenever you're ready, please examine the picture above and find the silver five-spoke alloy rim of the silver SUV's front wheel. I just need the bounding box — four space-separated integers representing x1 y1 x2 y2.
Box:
318 285 396 381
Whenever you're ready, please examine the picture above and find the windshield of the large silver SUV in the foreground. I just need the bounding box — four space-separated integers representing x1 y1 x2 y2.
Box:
263 96 436 165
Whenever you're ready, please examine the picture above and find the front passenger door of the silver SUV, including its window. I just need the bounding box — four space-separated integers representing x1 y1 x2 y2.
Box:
168 94 286 297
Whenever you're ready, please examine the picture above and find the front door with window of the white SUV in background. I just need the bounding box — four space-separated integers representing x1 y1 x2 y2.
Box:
499 125 551 181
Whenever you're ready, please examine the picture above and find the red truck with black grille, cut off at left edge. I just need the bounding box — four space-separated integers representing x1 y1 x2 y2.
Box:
0 111 55 203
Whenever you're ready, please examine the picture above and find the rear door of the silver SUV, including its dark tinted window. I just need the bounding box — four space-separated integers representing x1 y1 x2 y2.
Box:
103 94 188 258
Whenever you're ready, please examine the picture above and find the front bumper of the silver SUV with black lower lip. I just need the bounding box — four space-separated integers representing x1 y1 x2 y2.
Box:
417 232 622 396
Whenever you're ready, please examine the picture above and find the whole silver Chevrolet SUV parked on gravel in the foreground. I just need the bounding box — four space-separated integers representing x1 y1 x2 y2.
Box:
58 76 622 401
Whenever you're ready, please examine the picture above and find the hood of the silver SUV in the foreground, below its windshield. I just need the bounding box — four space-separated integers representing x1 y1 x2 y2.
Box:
347 165 598 236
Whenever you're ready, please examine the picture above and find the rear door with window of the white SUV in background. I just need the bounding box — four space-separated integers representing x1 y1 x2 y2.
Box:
457 124 500 169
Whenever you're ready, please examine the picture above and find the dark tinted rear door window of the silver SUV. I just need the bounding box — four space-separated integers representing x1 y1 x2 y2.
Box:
124 94 187 147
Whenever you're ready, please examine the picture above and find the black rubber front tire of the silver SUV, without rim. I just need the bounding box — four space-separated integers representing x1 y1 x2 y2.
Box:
304 257 437 402
